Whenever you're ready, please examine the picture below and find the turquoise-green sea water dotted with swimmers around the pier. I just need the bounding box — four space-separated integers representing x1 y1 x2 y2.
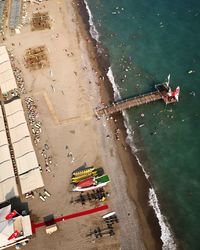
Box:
87 0 200 250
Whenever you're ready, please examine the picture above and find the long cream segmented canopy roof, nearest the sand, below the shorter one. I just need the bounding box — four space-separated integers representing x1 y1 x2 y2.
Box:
4 99 44 194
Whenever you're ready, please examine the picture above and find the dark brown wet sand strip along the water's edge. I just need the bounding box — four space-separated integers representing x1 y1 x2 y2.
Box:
74 0 163 249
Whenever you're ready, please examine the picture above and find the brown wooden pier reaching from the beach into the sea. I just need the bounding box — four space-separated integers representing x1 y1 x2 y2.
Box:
96 85 176 117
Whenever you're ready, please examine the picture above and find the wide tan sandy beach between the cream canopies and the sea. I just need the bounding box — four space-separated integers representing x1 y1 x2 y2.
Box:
2 0 161 250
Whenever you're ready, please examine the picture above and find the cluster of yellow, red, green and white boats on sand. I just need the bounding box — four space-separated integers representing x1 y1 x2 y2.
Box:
71 165 110 192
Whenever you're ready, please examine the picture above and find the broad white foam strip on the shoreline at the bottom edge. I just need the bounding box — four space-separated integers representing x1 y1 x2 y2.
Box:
149 188 177 250
